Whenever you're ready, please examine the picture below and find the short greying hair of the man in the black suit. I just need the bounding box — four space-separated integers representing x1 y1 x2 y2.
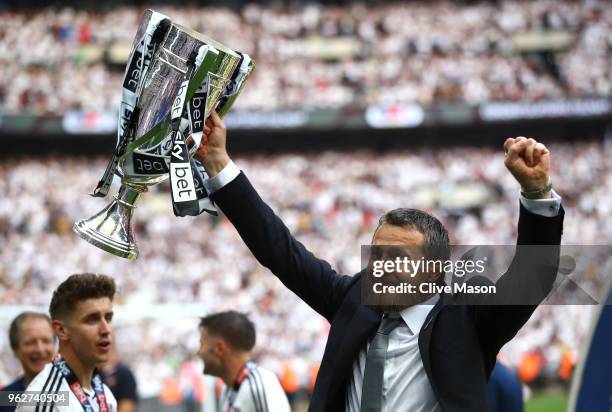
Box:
378 208 450 260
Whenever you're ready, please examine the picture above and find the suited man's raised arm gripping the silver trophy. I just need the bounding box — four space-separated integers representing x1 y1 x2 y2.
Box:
197 113 352 322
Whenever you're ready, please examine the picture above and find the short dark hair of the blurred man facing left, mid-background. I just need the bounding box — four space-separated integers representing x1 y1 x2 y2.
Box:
200 310 255 351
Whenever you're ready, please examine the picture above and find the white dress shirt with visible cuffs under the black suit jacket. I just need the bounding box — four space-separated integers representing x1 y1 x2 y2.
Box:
204 160 561 412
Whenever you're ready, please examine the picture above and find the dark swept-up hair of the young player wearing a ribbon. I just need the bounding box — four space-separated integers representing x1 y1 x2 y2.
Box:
49 273 116 319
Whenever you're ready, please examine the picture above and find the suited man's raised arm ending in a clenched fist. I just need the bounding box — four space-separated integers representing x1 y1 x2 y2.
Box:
474 137 564 353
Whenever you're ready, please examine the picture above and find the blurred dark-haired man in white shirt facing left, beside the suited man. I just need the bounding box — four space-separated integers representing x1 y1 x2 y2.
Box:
198 311 291 412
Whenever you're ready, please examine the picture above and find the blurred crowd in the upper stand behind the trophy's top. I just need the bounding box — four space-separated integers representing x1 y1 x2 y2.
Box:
0 0 612 115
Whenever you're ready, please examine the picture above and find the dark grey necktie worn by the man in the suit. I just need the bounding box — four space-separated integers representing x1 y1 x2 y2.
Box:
361 316 404 412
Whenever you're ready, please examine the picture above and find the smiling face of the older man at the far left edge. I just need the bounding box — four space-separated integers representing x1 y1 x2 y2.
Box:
15 318 53 376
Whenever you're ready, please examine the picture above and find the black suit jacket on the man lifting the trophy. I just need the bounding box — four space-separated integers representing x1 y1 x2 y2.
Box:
212 173 563 412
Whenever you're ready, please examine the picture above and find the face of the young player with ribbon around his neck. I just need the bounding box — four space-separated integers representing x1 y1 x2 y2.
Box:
66 297 113 367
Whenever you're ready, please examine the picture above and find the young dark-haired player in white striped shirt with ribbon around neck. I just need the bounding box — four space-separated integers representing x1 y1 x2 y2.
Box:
17 274 117 412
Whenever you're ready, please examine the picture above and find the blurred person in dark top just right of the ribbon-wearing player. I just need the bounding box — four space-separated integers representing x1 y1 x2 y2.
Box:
100 345 138 412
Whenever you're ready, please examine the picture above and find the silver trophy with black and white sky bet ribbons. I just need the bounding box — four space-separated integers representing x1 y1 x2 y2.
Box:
74 10 255 259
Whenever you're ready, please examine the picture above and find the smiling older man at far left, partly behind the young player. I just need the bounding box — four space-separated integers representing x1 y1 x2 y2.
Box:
0 312 54 412
